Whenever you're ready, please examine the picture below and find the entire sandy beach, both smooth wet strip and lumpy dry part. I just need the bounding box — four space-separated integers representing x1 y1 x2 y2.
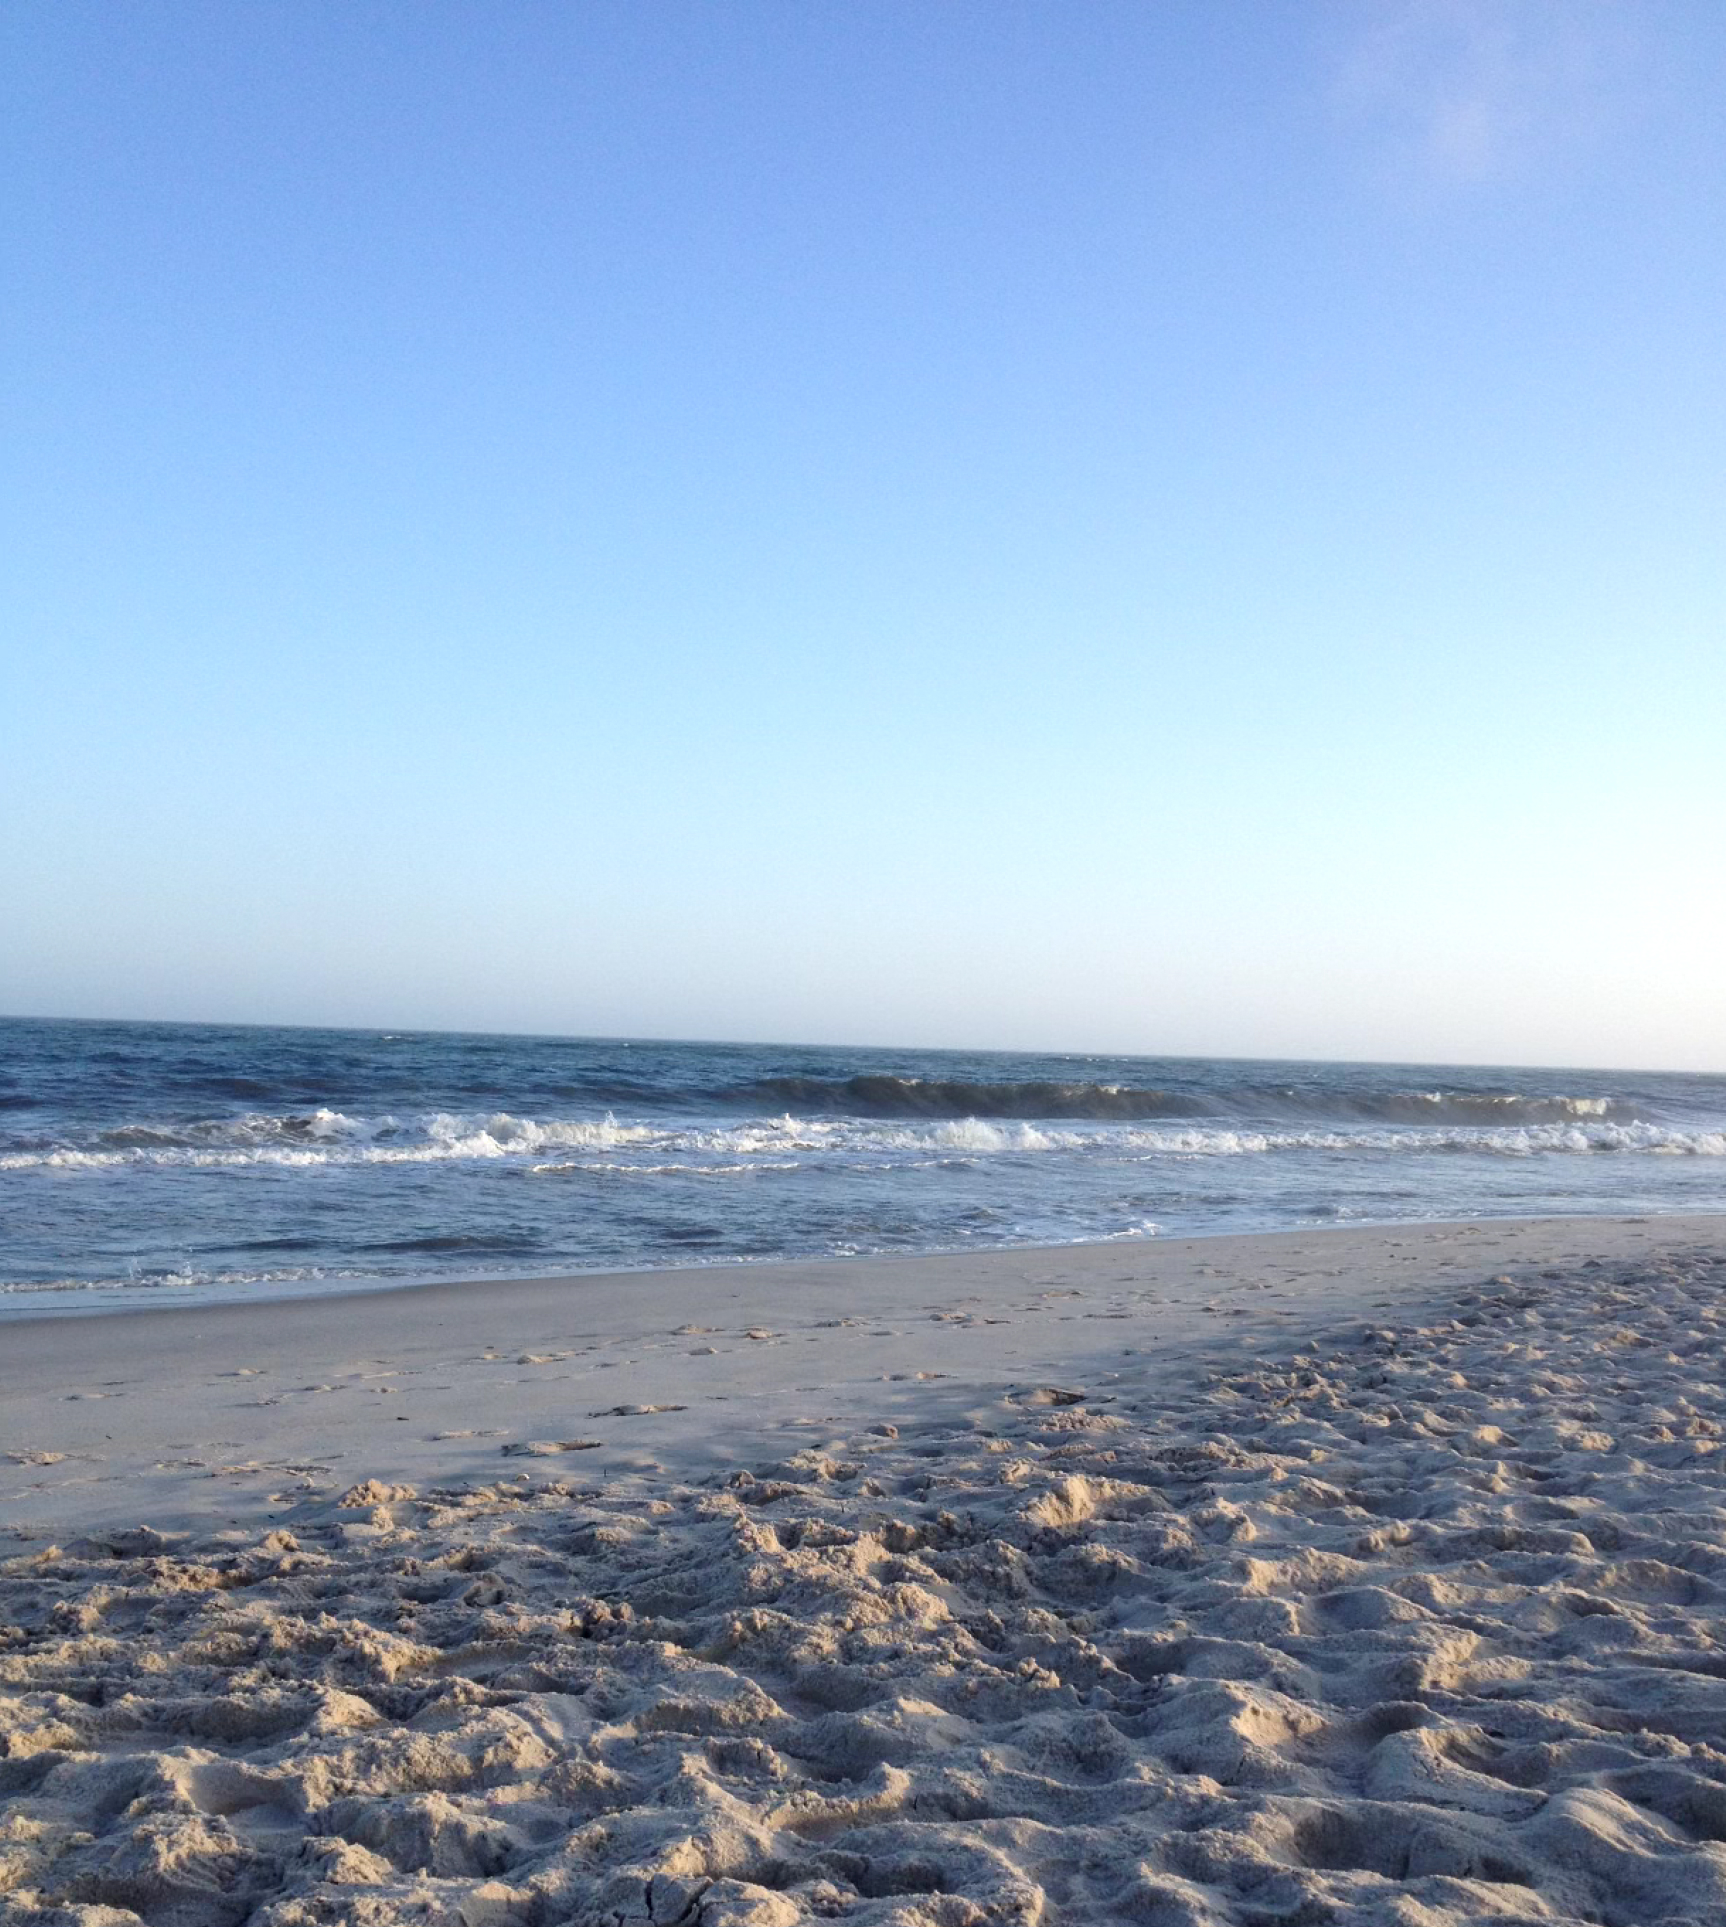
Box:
0 1218 1726 1927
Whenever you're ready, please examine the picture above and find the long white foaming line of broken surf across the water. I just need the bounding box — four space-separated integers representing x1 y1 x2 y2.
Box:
0 1100 1726 1170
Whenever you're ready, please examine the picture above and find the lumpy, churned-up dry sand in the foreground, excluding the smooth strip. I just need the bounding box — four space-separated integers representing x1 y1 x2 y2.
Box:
0 1256 1726 1927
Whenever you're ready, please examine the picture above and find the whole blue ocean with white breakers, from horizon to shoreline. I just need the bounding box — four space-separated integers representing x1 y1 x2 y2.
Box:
0 1019 1726 1312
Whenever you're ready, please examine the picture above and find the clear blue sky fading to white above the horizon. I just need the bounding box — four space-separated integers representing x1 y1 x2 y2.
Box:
0 0 1726 1069
